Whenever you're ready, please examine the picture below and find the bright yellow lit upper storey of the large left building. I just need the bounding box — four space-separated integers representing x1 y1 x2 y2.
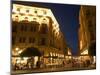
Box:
12 4 59 29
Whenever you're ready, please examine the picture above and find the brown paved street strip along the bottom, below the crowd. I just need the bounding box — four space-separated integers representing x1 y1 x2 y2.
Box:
12 67 95 75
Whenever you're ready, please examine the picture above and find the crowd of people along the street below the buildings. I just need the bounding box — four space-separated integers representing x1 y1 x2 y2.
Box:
12 59 91 70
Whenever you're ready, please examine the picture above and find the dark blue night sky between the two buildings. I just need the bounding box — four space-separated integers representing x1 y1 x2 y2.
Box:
14 1 80 55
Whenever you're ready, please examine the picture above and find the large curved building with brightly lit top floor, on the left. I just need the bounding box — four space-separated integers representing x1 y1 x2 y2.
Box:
12 4 66 64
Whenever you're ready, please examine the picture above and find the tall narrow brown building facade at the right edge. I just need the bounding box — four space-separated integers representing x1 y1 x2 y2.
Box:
79 6 96 62
